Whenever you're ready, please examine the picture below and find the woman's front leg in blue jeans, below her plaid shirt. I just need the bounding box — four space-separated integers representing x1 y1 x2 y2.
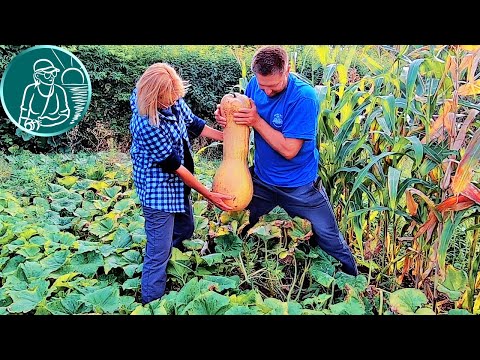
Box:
141 207 174 304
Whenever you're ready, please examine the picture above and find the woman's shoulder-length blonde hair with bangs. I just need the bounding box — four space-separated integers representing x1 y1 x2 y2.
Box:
137 63 189 126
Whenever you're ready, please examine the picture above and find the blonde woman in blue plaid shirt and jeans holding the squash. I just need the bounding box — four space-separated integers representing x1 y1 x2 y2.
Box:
130 63 232 304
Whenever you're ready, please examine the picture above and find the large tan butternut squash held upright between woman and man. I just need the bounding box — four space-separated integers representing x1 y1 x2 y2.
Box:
212 93 253 211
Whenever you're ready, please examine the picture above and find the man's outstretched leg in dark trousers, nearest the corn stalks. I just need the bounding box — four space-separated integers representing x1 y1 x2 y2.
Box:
277 183 358 275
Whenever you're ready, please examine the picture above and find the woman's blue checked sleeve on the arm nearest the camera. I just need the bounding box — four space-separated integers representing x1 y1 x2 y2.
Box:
142 124 173 162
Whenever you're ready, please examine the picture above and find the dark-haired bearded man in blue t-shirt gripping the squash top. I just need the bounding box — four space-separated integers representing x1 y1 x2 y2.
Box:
215 46 358 275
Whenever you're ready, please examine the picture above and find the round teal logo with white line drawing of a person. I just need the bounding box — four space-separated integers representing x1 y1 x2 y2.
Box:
0 45 92 136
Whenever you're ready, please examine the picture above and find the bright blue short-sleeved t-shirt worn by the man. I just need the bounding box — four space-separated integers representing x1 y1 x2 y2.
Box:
245 74 319 187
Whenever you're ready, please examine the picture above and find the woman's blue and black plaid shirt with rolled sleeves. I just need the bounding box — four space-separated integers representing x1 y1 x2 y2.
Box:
130 89 206 213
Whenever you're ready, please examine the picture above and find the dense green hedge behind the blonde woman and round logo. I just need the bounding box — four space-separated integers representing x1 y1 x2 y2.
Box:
0 45 241 153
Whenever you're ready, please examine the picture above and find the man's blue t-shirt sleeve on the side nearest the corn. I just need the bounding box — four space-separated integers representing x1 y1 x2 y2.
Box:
282 98 318 140
